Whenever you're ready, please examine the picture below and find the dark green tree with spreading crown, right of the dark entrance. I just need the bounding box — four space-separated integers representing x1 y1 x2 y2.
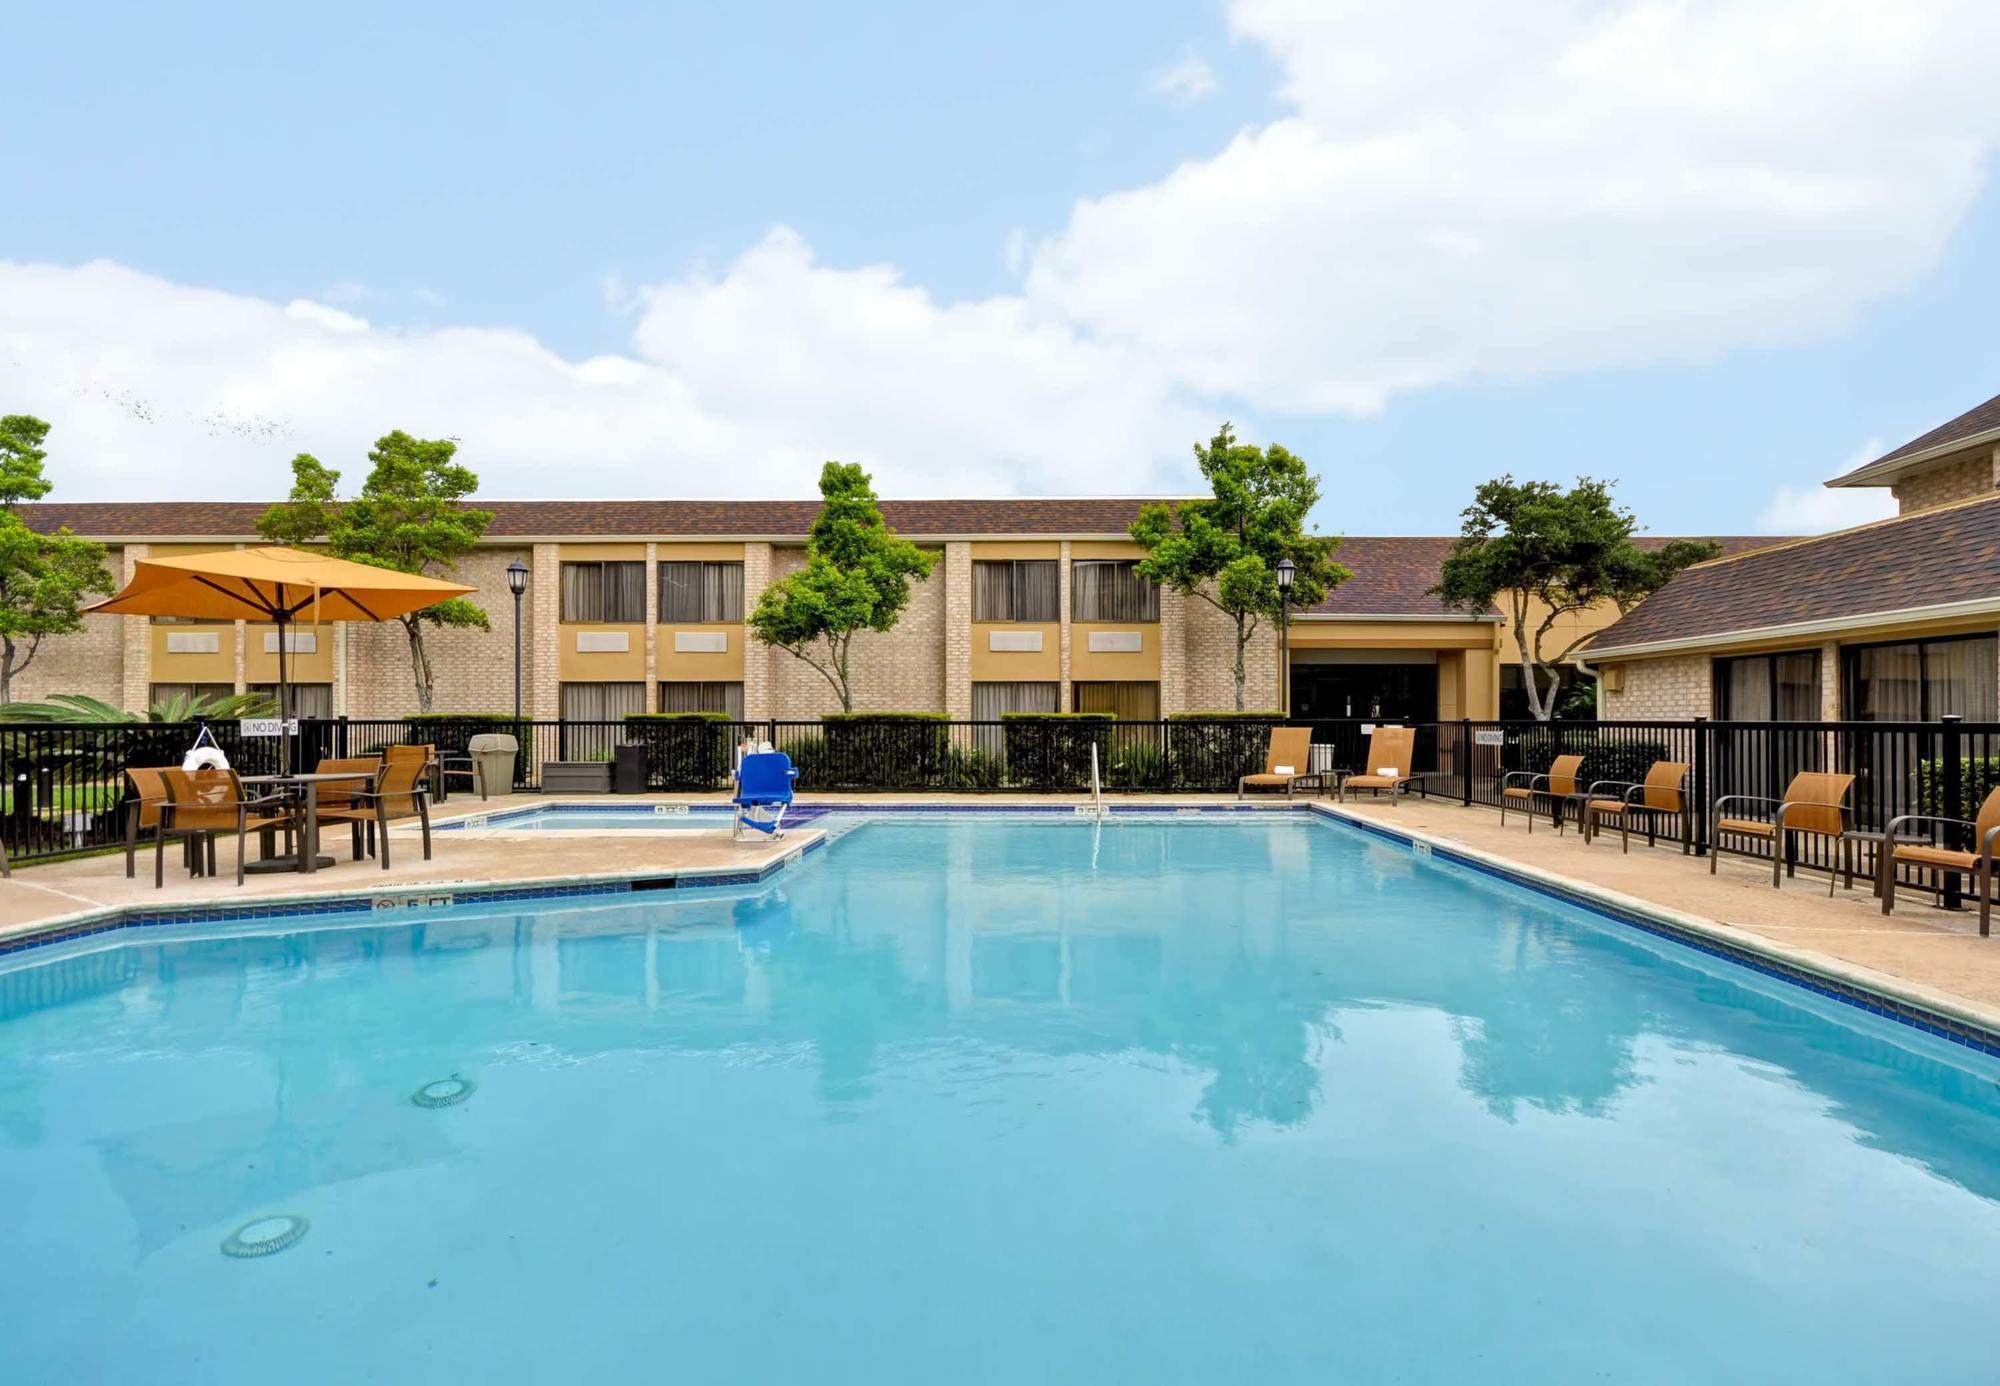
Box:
1430 476 1722 722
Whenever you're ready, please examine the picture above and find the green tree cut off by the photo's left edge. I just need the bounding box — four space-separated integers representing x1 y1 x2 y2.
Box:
0 414 112 704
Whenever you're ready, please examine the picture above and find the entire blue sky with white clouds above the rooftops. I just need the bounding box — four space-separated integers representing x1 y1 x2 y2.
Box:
0 0 2000 534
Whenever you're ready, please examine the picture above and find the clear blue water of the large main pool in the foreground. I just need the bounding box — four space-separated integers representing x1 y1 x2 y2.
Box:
0 816 2000 1384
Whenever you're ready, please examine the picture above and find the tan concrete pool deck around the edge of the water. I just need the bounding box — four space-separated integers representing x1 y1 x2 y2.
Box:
0 794 2000 1030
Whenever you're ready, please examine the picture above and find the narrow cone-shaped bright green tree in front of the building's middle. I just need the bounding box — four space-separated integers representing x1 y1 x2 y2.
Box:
748 462 938 712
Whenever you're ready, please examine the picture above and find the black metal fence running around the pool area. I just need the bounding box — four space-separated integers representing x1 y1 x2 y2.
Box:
11 716 2000 896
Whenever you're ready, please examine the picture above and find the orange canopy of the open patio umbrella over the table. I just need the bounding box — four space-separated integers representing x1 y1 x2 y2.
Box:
86 546 476 624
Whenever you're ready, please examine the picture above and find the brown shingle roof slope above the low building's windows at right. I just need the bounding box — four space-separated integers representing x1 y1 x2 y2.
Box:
1590 496 2000 656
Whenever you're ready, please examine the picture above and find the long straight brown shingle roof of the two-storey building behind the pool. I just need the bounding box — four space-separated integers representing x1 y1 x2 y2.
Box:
20 496 1146 540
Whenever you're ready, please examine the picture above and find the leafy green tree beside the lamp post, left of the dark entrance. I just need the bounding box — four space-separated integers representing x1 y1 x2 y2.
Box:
1130 424 1354 712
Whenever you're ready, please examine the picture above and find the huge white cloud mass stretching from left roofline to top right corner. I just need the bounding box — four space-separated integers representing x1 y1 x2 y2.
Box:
0 0 2000 508
